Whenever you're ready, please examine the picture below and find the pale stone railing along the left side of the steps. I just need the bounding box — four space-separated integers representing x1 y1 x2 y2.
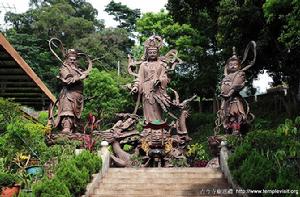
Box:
84 141 110 197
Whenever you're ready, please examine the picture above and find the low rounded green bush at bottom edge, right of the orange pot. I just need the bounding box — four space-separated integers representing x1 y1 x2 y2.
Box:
33 178 71 197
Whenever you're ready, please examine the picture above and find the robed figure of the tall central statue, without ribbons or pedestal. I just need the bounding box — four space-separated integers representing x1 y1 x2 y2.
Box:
131 36 171 124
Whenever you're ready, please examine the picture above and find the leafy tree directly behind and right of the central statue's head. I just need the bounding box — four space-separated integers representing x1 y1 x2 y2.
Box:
137 10 217 97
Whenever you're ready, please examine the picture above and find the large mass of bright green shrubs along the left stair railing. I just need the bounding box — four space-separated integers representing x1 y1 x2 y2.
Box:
33 149 102 197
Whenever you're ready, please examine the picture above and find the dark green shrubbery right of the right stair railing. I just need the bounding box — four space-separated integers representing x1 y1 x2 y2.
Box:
228 118 300 189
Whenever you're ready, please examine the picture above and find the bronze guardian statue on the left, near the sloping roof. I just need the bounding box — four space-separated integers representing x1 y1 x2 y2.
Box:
49 38 92 133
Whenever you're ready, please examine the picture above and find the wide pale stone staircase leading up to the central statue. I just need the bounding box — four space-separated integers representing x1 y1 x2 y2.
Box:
89 168 232 197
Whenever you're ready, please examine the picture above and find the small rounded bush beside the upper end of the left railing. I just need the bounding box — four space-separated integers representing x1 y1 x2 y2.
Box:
73 150 102 176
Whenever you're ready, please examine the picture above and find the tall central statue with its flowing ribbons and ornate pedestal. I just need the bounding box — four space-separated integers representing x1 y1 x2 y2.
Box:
113 36 195 166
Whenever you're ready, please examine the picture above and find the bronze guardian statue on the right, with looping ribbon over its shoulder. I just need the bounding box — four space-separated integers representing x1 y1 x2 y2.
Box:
217 41 256 134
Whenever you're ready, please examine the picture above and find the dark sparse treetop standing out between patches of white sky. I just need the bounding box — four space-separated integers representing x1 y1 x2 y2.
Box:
105 0 141 32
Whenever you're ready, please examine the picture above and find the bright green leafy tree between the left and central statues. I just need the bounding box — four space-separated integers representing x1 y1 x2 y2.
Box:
84 69 132 125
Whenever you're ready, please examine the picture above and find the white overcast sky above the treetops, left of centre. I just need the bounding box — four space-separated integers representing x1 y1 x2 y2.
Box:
0 0 168 27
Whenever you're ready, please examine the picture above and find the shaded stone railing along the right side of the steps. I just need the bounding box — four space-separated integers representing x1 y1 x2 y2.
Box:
220 141 248 197
